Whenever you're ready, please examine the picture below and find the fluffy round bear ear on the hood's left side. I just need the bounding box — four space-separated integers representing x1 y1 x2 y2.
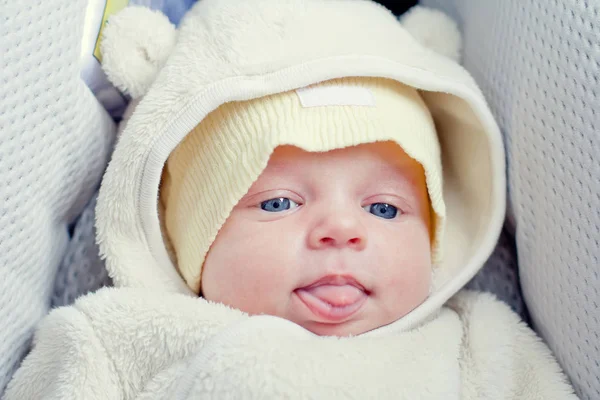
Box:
100 6 177 99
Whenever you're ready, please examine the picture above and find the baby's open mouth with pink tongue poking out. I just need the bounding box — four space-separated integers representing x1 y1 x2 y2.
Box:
295 275 369 323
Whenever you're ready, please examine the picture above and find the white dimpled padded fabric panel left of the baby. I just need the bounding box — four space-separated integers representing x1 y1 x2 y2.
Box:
0 0 114 393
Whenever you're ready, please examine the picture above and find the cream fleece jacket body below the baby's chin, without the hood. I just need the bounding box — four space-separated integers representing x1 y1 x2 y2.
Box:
5 288 576 400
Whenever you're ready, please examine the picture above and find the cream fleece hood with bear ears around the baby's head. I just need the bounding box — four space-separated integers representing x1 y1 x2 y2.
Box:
97 0 506 329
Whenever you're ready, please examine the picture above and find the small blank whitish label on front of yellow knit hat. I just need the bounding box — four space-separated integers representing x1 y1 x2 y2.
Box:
296 85 375 108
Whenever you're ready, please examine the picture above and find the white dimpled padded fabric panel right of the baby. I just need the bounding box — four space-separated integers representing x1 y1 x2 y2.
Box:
424 0 600 399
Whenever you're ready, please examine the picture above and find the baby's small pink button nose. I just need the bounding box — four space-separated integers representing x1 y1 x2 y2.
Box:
308 214 367 250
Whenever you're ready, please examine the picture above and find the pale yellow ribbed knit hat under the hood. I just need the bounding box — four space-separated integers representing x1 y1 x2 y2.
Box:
160 78 446 293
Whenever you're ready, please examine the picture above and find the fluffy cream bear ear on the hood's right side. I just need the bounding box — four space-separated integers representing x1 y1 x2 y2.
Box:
398 6 462 62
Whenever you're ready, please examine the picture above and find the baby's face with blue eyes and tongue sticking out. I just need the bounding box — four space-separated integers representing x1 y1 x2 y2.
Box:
202 143 431 336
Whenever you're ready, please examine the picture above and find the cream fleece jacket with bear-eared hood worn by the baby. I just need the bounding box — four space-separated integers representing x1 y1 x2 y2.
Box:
5 0 575 400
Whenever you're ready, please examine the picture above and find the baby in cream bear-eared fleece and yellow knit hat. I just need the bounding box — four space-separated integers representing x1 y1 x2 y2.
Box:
5 0 575 400
